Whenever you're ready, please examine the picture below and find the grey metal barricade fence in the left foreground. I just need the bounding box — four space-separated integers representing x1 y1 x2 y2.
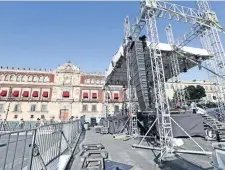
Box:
0 120 82 170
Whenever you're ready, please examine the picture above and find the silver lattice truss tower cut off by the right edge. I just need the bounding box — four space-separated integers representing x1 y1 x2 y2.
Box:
197 0 225 117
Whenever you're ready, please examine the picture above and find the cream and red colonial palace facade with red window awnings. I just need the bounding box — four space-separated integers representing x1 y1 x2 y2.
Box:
0 62 123 120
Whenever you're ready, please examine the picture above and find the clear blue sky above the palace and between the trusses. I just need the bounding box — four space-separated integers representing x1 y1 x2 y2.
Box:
0 2 225 79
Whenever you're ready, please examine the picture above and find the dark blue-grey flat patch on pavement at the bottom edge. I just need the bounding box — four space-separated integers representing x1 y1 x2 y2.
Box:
105 160 133 170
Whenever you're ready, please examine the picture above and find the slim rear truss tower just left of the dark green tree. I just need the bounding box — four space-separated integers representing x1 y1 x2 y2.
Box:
165 25 186 106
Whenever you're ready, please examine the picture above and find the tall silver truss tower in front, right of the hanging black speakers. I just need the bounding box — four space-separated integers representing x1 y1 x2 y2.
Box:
145 10 173 160
